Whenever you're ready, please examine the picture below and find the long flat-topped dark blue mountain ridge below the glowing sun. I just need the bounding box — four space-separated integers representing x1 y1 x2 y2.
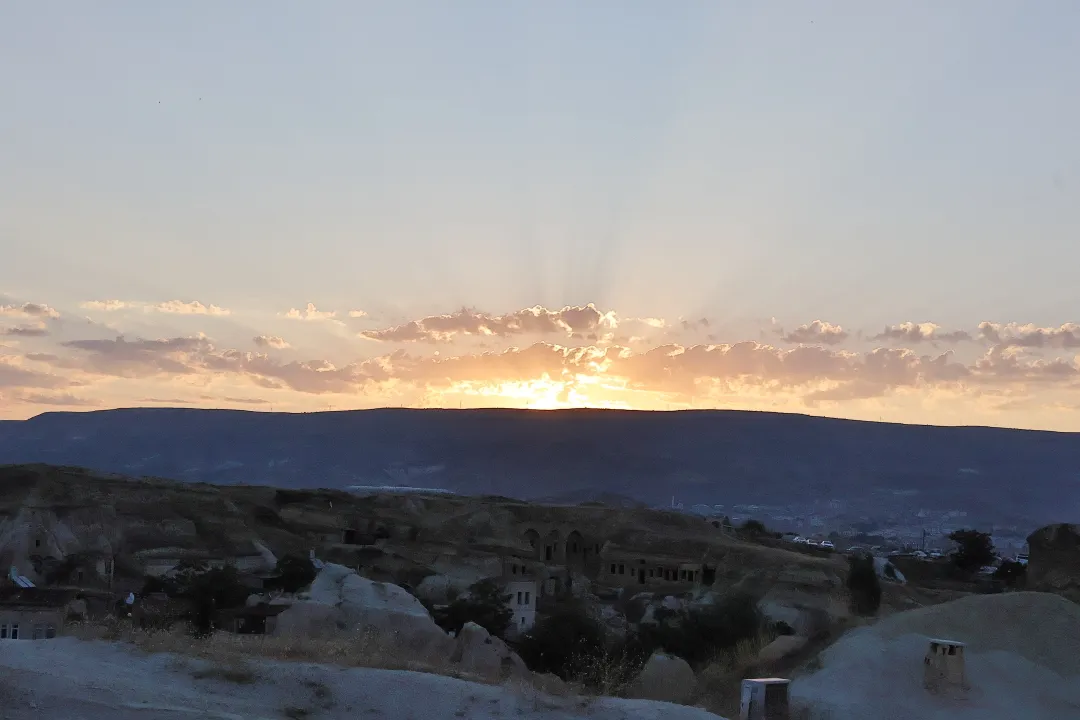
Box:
0 408 1080 520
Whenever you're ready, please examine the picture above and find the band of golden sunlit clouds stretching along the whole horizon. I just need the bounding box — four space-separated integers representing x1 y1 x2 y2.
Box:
0 300 1080 422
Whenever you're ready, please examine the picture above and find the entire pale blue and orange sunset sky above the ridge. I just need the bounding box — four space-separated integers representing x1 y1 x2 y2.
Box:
0 0 1080 431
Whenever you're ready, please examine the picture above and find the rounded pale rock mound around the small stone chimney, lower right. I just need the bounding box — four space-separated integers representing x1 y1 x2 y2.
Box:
791 593 1080 720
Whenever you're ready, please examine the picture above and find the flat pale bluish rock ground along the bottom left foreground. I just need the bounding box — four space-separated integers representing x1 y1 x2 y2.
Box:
0 638 721 720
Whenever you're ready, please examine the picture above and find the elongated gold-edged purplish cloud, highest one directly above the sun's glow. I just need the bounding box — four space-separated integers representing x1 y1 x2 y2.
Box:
360 303 618 342
